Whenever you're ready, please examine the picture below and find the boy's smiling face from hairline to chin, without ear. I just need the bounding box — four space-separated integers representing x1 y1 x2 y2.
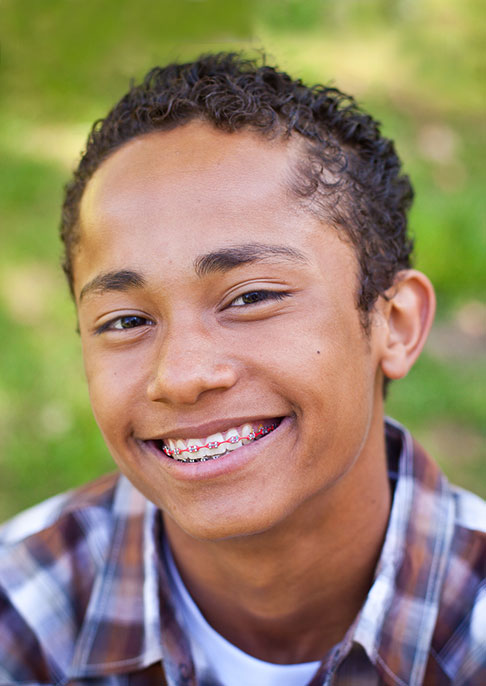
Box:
74 123 390 539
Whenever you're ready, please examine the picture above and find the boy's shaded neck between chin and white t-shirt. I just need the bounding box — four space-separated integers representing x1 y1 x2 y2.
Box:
165 416 391 664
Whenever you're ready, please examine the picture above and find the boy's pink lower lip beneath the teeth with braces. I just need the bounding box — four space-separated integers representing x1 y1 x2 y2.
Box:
137 417 292 481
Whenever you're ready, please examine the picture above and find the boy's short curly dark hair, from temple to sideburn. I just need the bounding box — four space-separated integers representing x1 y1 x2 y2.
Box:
61 53 413 329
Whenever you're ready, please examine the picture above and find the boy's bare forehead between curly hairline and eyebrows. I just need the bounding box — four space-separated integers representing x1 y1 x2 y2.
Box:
74 122 354 296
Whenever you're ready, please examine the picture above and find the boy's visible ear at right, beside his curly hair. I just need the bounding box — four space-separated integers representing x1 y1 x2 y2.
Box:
381 269 435 379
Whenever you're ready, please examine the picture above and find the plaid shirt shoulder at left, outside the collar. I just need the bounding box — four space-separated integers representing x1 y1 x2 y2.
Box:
0 474 120 683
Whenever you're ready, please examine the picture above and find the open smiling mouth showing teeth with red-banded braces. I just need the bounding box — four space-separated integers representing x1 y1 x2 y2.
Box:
151 419 282 462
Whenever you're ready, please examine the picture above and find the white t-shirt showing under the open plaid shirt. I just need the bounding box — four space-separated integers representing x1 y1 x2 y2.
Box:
164 541 320 686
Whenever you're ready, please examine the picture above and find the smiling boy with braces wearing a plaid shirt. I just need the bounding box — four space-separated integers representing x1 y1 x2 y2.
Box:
0 54 486 686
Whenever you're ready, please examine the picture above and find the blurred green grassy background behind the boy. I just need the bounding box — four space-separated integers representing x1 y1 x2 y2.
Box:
0 0 486 520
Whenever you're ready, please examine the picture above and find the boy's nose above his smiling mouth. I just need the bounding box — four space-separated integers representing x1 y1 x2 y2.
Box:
147 329 237 405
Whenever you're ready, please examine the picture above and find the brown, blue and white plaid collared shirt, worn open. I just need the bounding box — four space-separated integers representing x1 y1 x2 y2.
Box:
0 422 486 686
